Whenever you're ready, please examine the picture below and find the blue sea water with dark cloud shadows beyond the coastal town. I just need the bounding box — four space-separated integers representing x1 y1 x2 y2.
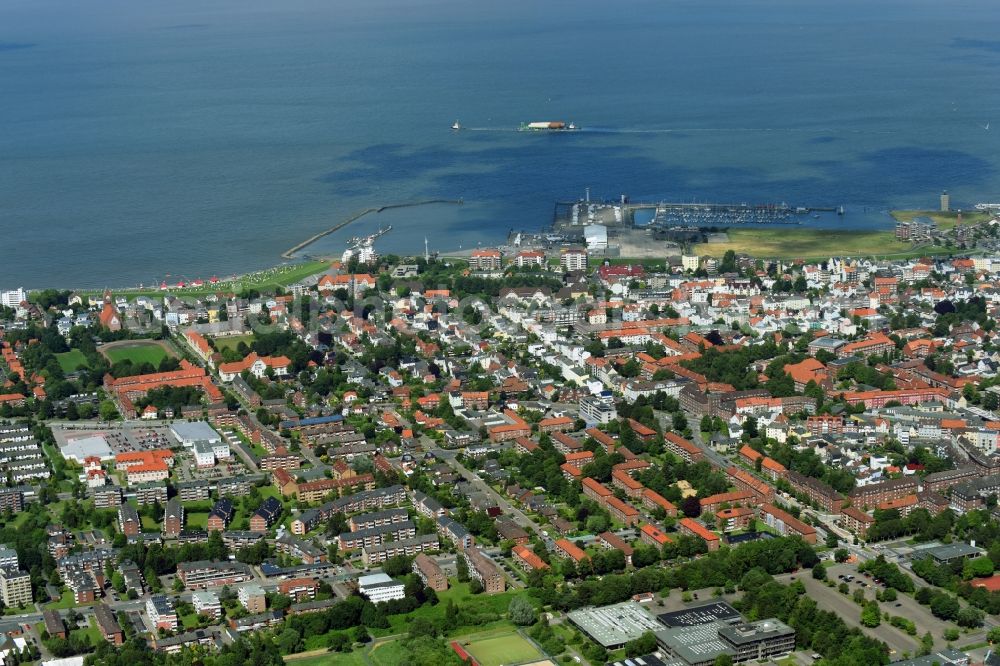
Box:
0 0 1000 287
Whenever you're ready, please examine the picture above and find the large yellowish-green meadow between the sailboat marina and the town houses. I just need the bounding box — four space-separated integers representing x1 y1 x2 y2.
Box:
692 227 920 259
